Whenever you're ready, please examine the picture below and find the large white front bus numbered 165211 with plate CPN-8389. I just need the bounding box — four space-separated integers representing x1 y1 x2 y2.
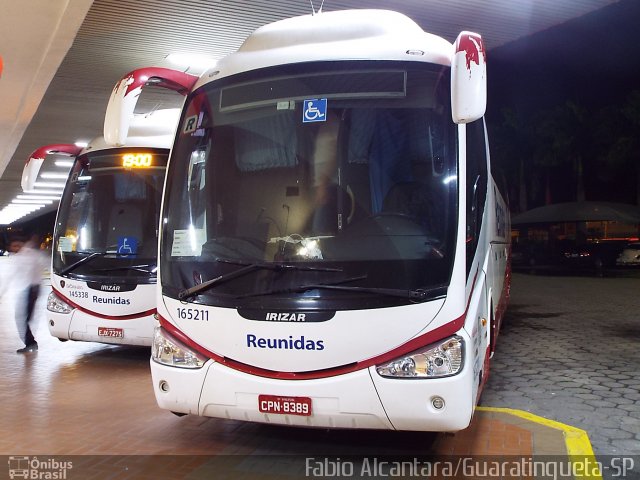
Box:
113 10 510 431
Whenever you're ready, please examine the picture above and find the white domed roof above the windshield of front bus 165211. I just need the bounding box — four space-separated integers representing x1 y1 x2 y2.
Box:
195 9 454 88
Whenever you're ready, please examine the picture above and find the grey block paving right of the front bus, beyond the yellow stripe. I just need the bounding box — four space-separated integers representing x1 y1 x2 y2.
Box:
481 274 640 458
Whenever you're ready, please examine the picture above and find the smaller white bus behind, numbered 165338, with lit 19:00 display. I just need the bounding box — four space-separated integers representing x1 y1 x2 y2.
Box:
23 109 179 345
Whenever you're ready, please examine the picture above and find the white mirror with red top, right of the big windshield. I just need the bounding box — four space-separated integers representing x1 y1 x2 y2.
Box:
451 32 487 123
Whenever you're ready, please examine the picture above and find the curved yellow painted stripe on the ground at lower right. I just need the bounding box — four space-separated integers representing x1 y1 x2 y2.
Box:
476 407 602 480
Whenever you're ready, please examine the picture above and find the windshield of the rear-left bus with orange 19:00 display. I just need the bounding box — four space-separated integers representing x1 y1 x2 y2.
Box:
53 147 168 283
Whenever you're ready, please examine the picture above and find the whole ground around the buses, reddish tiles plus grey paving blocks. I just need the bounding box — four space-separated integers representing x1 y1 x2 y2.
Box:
0 259 640 479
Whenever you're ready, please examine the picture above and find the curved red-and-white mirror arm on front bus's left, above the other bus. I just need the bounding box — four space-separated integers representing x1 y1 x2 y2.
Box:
104 67 198 146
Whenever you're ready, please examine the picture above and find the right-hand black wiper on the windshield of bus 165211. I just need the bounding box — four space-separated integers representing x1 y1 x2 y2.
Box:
242 282 447 302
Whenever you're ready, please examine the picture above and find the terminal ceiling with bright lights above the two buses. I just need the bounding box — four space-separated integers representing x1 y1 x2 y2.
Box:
0 0 616 225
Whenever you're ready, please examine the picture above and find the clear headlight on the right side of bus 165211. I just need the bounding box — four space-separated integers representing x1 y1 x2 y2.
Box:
376 335 464 378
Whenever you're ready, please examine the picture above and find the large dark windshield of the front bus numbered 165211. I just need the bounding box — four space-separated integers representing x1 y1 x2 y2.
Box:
161 61 458 309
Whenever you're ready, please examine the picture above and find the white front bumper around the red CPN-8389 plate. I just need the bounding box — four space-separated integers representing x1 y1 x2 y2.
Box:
151 348 474 431
